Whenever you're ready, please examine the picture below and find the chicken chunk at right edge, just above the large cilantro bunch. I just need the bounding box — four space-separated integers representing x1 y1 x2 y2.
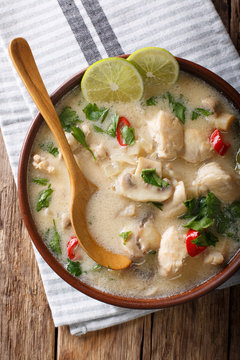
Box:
192 162 240 202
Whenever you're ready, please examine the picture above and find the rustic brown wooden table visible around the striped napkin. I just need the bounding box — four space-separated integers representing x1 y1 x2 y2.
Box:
0 0 240 360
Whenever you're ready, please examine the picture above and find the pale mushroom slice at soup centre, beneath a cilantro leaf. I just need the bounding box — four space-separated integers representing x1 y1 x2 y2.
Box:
115 172 173 202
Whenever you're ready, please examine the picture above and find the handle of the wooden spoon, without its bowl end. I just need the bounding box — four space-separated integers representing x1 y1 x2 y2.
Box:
8 38 85 183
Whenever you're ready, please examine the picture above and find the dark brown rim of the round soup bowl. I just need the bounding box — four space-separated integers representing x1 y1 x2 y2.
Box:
18 55 240 309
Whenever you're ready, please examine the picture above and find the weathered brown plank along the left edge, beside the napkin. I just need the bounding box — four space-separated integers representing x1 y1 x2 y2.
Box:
0 129 55 360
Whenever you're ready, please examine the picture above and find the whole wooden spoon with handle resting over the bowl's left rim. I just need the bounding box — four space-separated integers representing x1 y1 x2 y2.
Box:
9 38 131 270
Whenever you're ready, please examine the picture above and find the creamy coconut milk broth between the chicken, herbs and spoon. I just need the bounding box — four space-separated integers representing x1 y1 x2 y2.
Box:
28 72 239 298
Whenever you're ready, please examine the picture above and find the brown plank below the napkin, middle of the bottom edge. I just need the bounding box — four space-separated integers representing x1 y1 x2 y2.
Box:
57 315 151 360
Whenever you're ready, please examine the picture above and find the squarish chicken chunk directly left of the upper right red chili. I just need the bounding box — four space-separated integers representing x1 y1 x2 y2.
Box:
181 128 213 163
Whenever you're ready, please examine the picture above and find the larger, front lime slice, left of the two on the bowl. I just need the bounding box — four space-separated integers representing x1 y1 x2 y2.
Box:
81 58 143 102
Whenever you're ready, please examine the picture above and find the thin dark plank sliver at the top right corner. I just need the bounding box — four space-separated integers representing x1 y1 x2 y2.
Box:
230 0 240 54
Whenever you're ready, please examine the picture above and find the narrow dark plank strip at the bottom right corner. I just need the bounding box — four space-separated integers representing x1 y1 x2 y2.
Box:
229 285 240 360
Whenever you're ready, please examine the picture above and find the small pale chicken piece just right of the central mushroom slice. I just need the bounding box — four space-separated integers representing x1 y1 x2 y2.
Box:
161 181 186 217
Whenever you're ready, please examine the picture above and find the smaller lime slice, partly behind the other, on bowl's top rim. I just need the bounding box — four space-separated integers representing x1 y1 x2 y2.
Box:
128 47 179 85
